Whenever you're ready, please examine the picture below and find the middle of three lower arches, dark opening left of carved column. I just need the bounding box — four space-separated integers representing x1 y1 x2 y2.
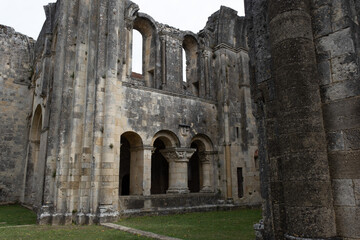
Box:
151 130 180 194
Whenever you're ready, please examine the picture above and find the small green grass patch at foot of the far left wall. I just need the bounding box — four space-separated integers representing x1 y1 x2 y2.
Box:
0 205 36 227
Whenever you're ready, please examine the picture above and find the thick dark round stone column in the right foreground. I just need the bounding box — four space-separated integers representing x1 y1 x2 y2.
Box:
267 0 336 239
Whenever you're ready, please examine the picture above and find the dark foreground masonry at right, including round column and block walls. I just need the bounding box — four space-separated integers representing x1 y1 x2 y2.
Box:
246 1 360 239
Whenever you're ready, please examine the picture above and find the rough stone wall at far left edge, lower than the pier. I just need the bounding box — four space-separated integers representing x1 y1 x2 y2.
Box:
0 25 34 202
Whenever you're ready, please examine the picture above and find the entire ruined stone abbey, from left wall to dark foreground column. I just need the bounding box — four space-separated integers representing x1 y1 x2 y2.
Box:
0 0 360 240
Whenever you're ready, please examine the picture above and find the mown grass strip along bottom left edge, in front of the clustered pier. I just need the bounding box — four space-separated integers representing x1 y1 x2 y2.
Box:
0 225 147 240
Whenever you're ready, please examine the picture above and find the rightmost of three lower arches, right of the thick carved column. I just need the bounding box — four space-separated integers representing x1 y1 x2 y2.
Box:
188 134 213 192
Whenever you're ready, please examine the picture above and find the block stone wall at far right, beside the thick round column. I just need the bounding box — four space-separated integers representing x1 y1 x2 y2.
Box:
312 1 360 239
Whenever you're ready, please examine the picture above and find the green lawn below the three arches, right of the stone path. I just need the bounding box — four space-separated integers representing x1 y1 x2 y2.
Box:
118 209 261 240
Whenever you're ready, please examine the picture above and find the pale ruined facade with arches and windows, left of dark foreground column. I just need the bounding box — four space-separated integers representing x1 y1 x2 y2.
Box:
0 0 261 224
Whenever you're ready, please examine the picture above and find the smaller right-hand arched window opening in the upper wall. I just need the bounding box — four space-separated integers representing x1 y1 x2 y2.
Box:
182 34 200 96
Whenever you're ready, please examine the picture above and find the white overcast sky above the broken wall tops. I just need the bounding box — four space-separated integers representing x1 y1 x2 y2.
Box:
0 0 244 39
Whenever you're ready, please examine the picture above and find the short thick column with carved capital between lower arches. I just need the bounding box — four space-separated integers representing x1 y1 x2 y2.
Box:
160 148 196 193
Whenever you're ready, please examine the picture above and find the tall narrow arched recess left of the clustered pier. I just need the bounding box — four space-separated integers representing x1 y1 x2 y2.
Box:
24 105 44 205
